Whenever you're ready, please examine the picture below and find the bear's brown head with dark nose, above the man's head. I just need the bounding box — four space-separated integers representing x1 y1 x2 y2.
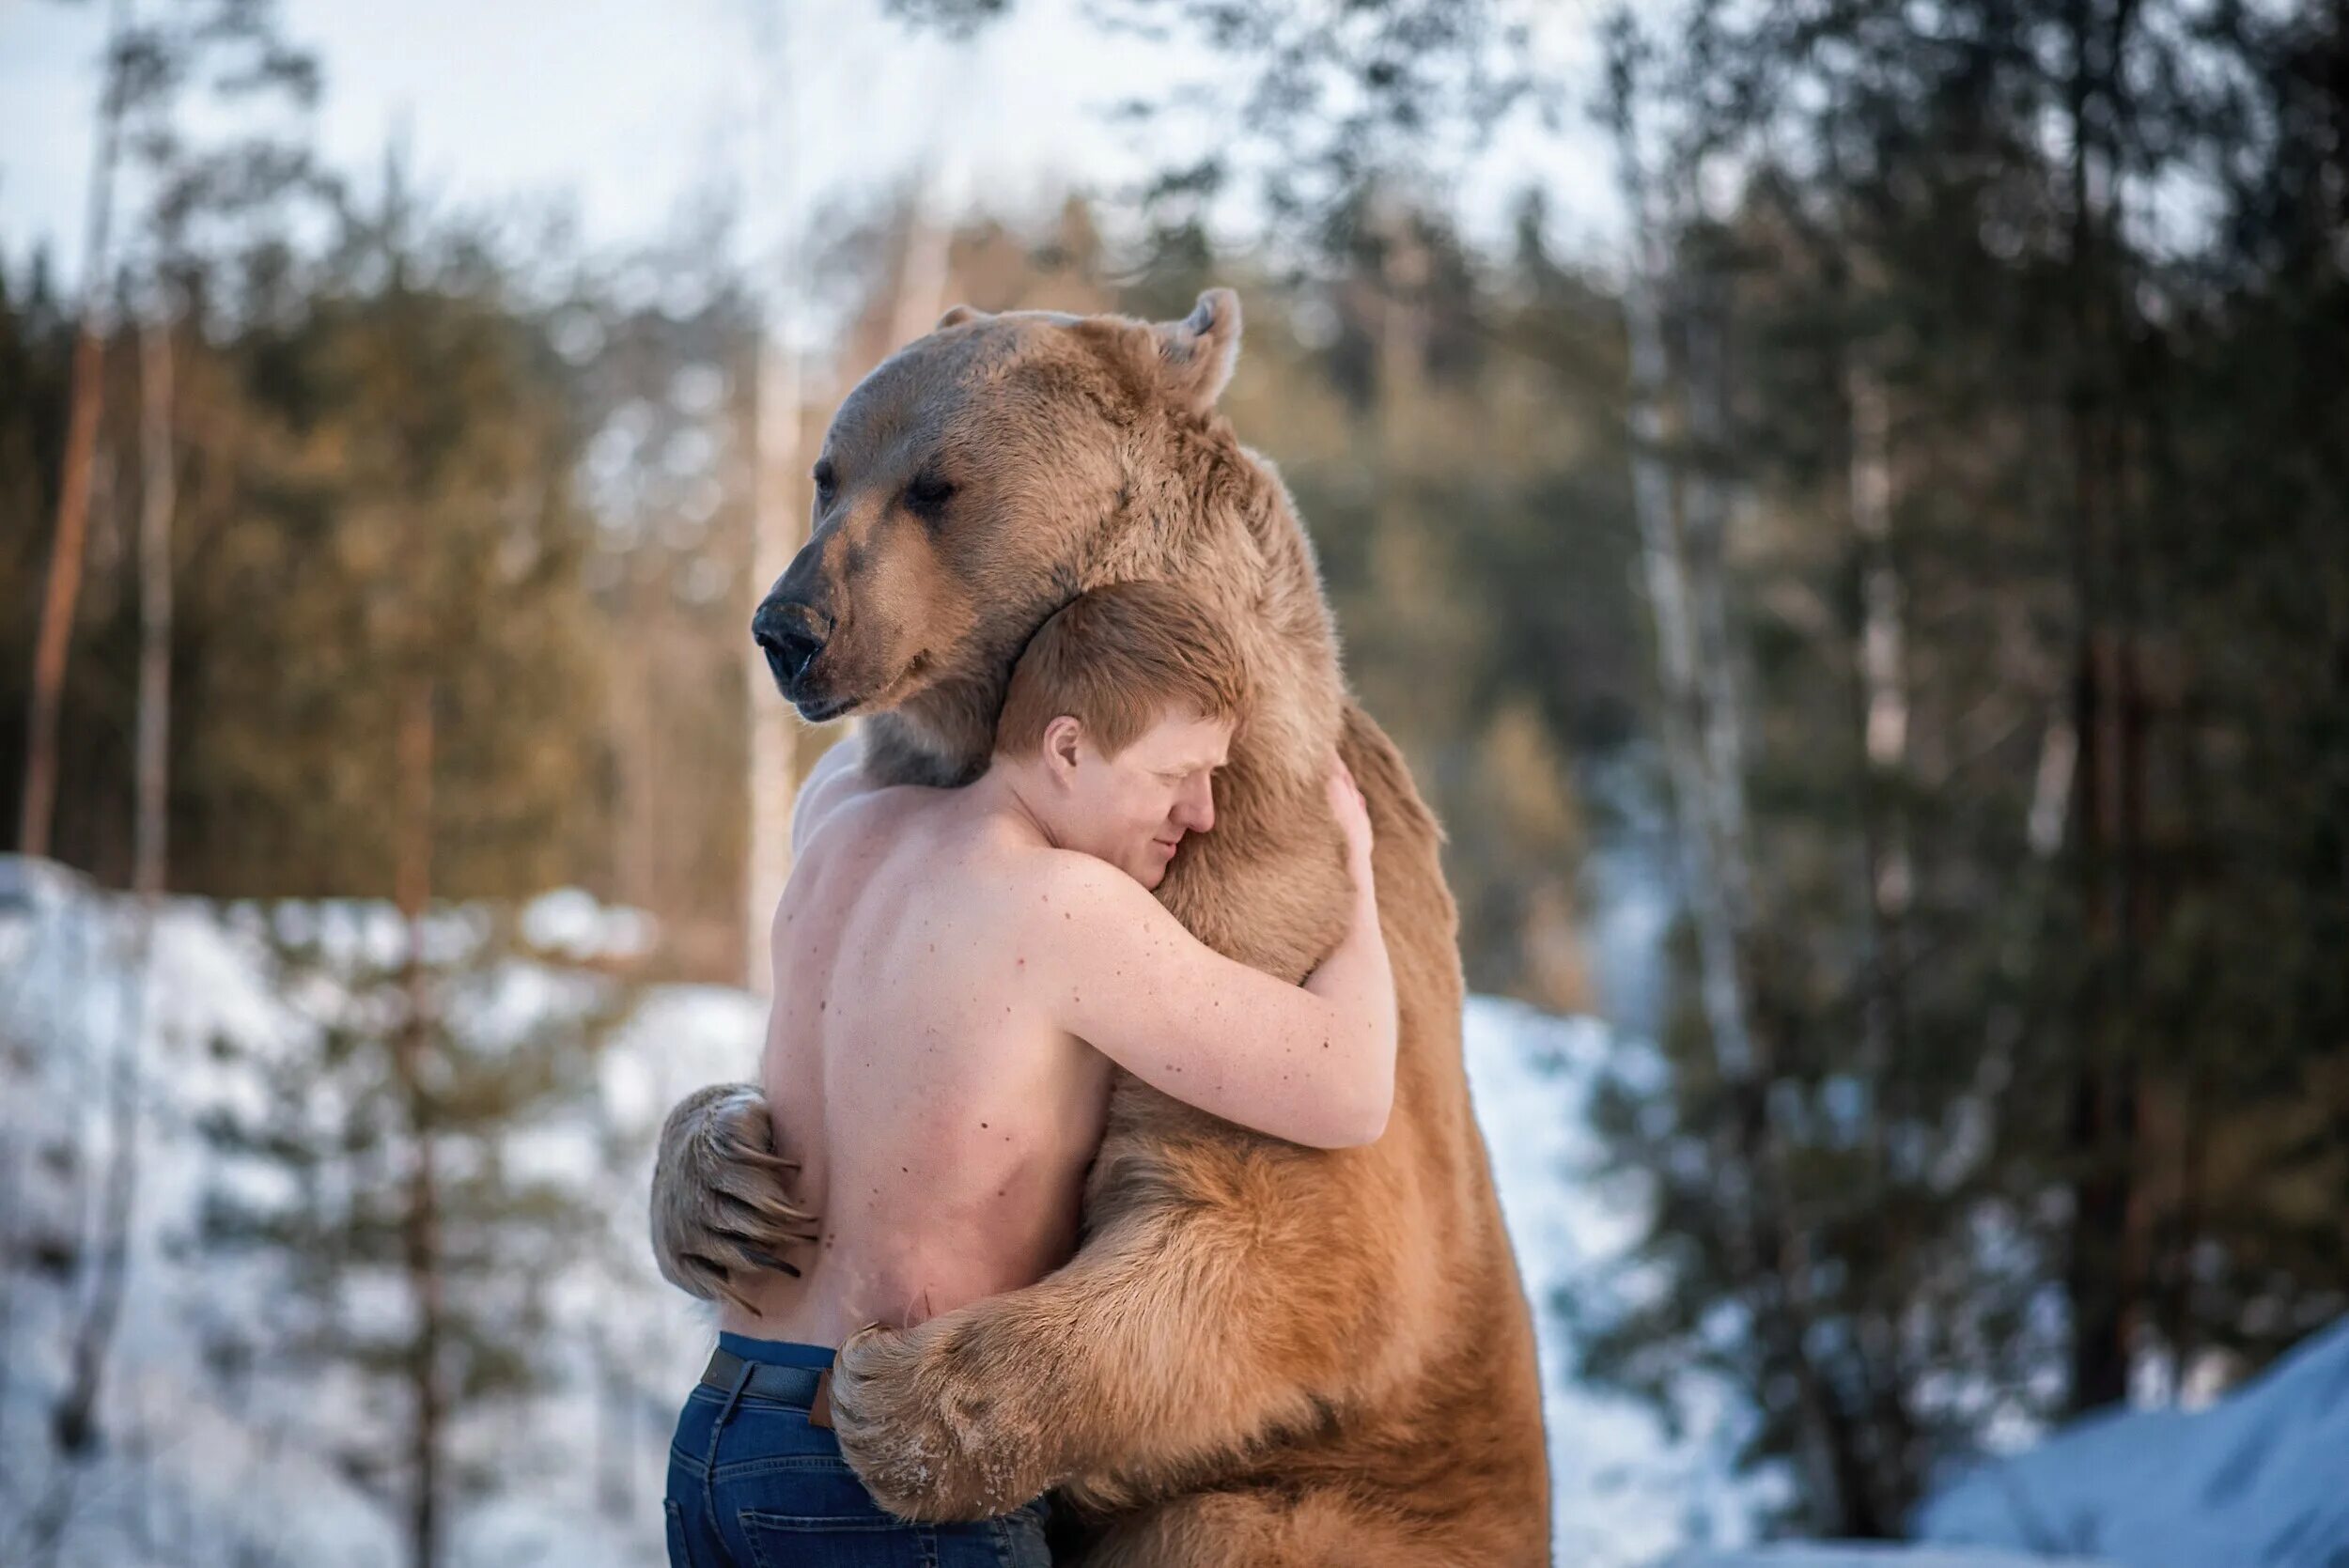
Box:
752 288 1268 772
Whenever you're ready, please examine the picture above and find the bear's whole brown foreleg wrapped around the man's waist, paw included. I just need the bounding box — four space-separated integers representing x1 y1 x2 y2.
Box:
832 1131 1403 1521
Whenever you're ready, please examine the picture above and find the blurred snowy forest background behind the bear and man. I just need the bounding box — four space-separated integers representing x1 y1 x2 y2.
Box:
0 0 2349 1568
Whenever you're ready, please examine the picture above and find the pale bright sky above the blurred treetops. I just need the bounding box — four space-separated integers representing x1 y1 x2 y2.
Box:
0 0 1619 300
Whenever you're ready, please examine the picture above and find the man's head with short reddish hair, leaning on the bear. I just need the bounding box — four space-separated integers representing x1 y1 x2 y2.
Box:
996 582 1245 887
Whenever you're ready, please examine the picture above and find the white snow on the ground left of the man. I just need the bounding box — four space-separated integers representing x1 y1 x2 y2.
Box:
0 857 742 1568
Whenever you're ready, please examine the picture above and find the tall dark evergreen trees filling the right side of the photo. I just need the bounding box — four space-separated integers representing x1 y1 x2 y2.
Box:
1560 5 2349 1535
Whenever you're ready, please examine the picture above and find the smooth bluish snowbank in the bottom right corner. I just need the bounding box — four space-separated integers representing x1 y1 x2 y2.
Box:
1917 1319 2349 1568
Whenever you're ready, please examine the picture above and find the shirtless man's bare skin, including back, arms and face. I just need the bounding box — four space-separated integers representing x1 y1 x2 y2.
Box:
722 690 1395 1345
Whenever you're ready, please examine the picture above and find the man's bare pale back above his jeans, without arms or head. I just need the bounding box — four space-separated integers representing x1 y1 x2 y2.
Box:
723 765 1109 1345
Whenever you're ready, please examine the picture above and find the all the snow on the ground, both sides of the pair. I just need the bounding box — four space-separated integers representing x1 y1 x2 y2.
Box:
37 857 2349 1568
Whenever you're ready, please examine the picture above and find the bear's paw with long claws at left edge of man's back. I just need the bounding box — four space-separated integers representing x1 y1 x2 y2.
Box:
653 1084 817 1314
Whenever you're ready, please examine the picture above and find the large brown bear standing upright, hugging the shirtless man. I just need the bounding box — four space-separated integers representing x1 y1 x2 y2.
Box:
656 288 1550 1568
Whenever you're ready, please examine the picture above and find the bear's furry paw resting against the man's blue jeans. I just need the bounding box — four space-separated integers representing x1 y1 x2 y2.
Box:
832 1298 1066 1521
